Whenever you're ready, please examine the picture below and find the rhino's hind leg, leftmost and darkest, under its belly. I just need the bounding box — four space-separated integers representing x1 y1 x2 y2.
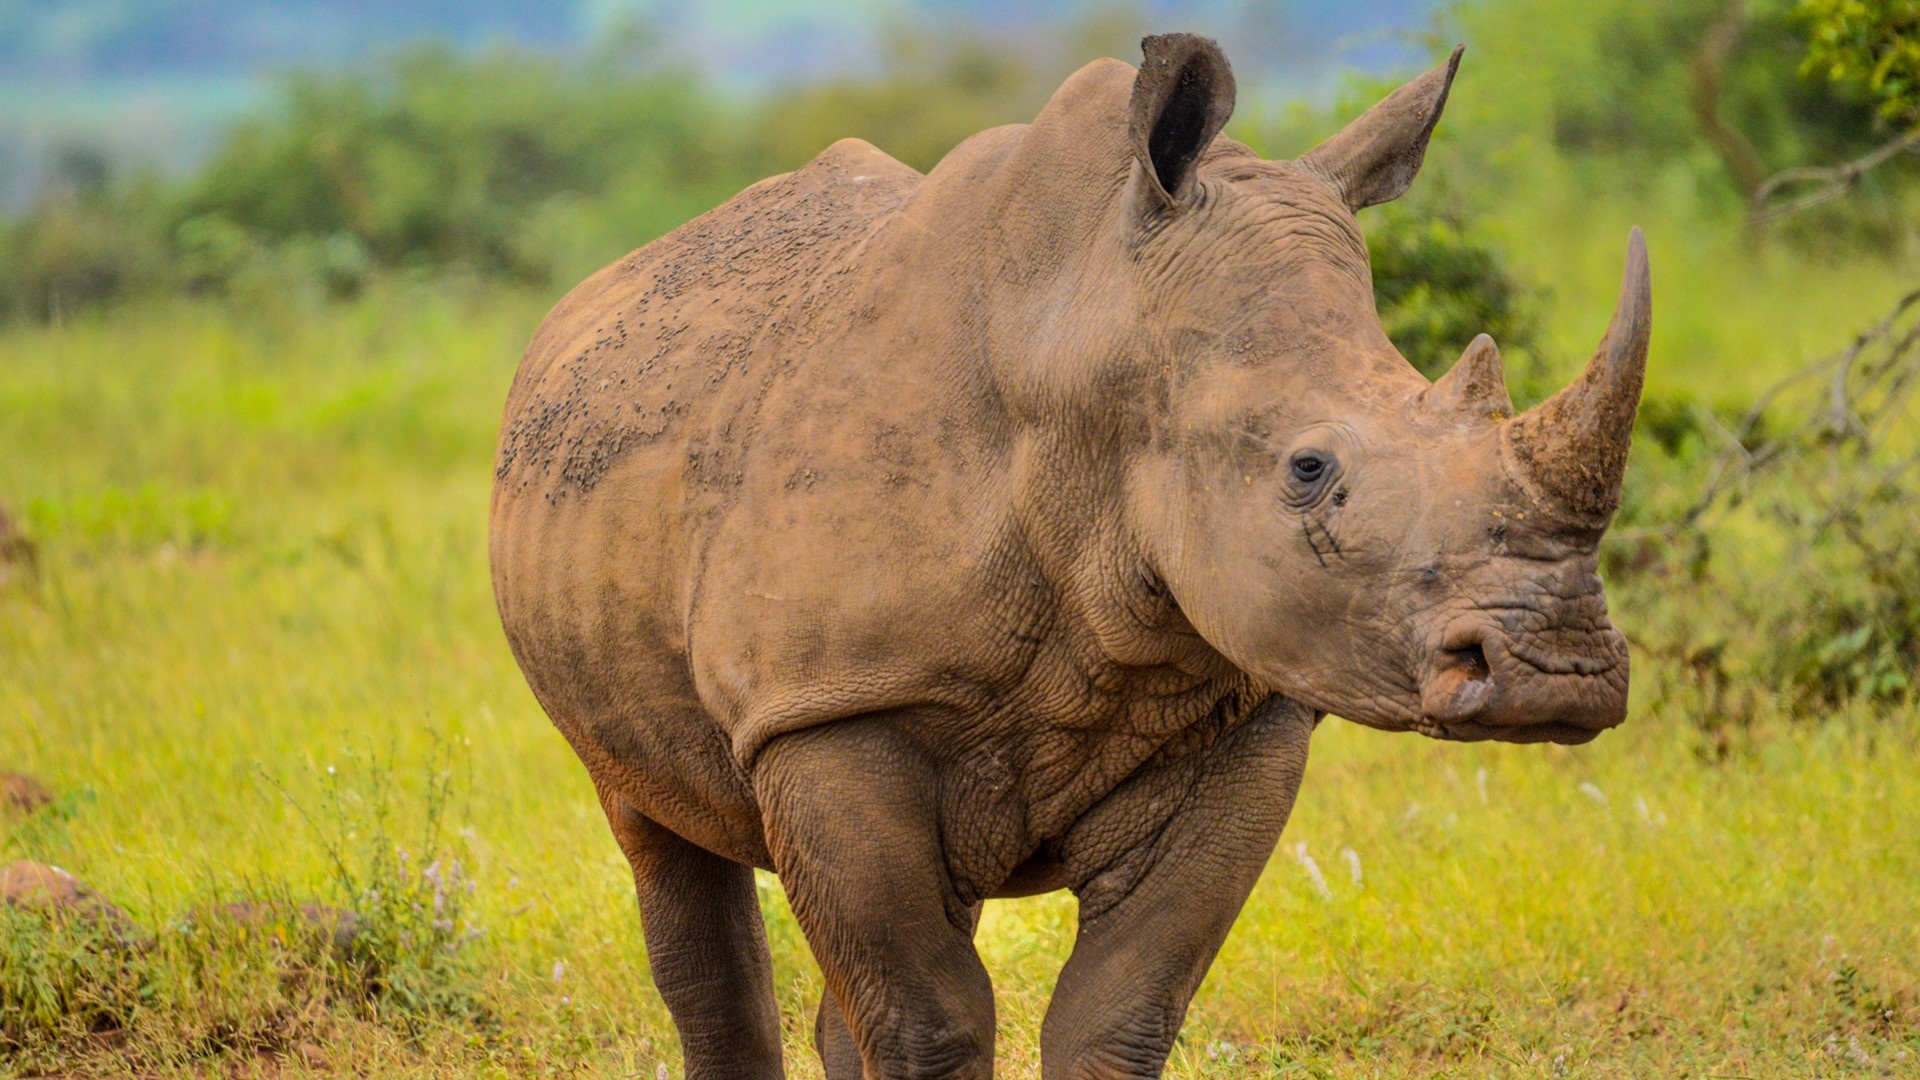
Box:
601 792 785 1080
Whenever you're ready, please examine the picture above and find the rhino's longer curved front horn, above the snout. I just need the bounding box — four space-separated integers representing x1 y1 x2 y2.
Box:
1507 229 1653 527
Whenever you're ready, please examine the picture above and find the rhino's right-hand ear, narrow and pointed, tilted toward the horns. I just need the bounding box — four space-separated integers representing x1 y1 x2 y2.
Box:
1300 46 1467 211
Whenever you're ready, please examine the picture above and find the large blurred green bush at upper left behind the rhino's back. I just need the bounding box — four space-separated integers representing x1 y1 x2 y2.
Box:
180 46 747 281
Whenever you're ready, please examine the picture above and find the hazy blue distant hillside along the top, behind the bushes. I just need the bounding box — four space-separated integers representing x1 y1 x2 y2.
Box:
0 0 1440 206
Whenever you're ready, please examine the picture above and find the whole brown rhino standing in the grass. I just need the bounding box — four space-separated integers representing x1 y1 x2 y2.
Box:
490 35 1651 1078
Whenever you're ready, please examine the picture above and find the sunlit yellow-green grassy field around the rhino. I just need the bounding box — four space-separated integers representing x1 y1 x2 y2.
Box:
0 261 1920 1076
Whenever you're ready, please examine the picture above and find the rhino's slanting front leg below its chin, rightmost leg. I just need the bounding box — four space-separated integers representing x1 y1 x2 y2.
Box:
1041 698 1317 1080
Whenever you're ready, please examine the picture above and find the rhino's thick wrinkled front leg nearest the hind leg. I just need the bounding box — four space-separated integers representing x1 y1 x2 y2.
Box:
753 717 993 1080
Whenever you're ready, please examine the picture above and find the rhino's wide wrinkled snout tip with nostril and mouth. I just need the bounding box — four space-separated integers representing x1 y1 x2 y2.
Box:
1421 625 1626 744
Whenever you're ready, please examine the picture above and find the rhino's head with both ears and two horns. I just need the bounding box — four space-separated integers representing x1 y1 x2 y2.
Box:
1021 35 1651 744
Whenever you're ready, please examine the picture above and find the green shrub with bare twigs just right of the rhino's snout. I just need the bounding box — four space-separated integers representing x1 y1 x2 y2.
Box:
1609 292 1920 723
